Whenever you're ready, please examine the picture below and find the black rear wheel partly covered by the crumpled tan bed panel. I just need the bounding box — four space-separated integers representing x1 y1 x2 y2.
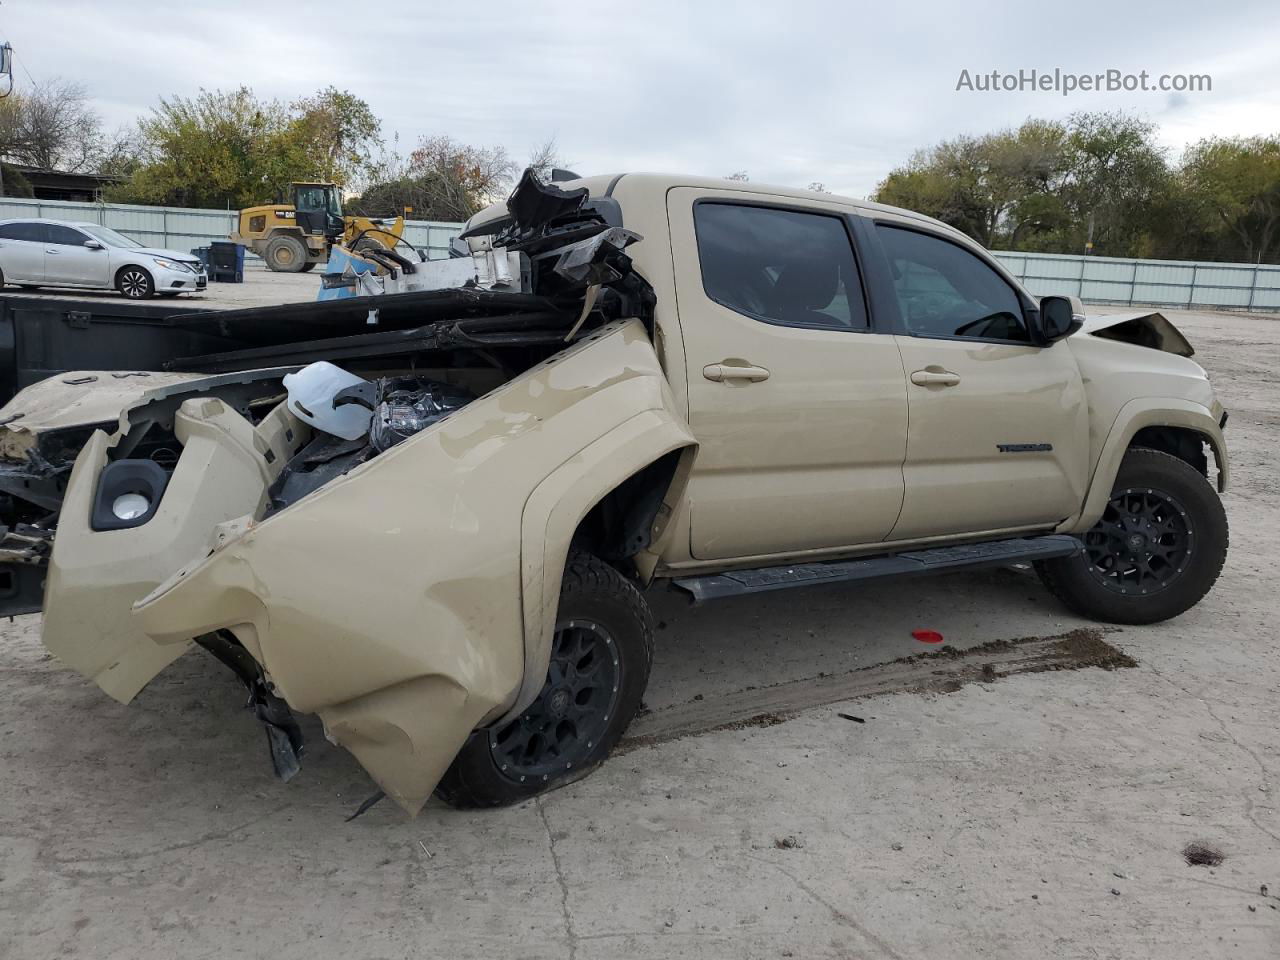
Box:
436 550 653 808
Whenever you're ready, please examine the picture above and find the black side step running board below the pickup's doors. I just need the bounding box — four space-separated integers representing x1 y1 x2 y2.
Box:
671 534 1082 603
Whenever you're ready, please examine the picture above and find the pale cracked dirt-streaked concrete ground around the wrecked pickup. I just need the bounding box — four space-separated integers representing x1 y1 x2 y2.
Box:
0 311 1280 960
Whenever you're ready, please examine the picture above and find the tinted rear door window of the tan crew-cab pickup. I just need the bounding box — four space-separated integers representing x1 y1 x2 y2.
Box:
694 204 867 330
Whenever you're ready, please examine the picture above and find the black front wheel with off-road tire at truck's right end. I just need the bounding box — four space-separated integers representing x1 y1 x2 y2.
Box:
1036 448 1229 623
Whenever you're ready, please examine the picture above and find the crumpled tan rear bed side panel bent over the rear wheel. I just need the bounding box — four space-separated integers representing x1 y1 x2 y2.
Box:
134 321 691 814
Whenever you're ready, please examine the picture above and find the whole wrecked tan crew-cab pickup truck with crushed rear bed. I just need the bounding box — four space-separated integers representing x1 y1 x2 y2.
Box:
0 174 1228 813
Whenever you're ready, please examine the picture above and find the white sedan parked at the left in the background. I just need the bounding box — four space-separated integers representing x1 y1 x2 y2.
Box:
0 220 209 300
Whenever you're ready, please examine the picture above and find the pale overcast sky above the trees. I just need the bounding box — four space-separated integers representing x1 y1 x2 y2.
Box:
0 0 1280 196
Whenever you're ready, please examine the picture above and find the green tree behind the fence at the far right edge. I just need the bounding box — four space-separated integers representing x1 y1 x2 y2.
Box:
1181 136 1280 264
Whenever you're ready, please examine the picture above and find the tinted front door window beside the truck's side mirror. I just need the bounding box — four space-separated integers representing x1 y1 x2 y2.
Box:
877 224 1030 342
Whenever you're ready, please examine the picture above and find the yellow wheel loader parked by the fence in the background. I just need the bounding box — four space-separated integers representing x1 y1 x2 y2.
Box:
232 183 404 274
